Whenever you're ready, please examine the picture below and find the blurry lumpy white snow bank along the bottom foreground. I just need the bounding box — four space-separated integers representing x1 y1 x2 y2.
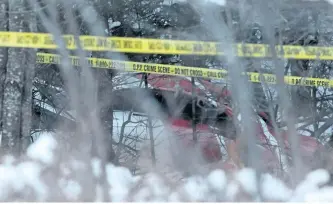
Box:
0 134 333 202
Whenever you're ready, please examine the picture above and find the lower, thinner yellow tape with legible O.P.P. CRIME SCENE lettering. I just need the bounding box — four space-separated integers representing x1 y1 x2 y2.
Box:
36 53 333 88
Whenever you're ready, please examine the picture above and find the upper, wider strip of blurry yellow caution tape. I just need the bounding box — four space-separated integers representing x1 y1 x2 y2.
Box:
0 32 333 60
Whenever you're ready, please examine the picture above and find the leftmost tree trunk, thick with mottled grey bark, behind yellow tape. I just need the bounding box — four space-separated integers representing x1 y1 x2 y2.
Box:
2 0 35 155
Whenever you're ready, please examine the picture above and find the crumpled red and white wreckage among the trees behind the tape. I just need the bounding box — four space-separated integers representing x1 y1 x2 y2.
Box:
32 74 324 178
